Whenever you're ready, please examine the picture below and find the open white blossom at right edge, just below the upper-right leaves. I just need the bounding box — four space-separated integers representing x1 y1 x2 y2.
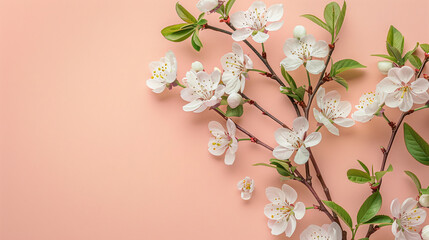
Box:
377 66 429 112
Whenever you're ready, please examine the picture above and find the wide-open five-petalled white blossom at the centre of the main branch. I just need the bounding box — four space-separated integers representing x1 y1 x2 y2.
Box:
273 117 322 164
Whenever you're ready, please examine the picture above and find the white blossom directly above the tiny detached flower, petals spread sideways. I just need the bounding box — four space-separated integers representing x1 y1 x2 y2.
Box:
208 119 238 165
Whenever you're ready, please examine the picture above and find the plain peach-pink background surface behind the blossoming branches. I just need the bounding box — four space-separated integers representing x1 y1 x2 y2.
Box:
0 0 429 240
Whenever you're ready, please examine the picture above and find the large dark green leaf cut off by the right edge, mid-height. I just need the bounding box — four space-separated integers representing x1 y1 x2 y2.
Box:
404 123 429 166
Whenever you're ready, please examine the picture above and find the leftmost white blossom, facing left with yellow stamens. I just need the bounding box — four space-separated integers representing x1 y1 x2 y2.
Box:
146 51 177 93
